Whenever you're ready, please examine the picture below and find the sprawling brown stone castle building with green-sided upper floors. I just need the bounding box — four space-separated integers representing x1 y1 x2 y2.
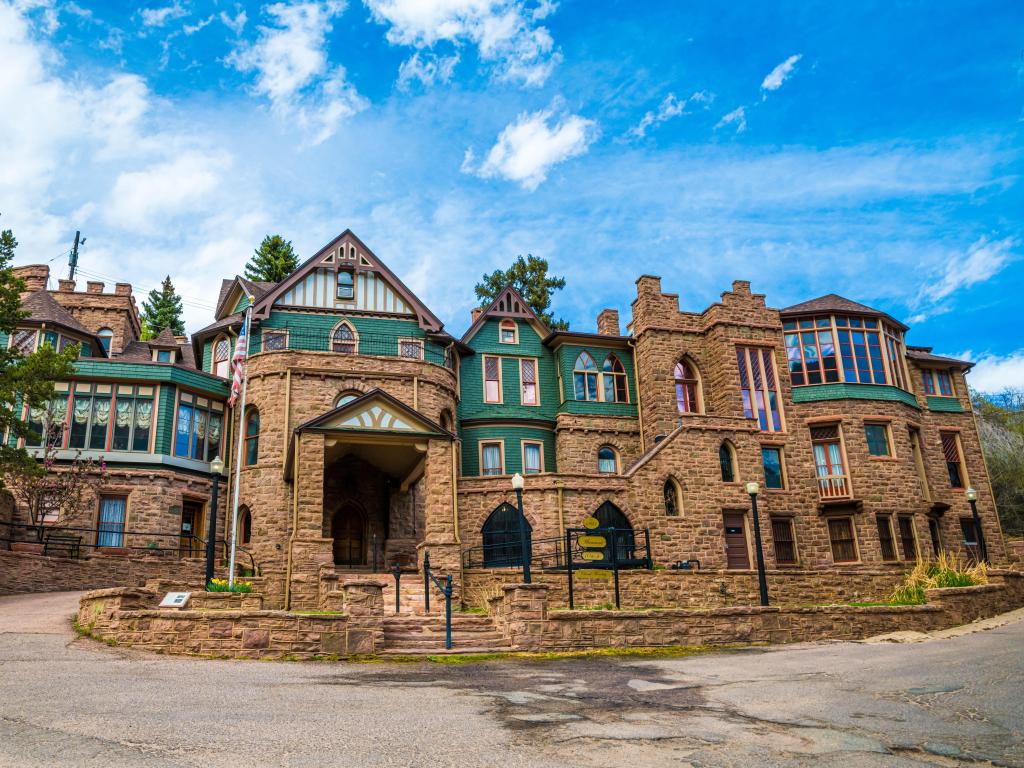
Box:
2 231 1007 608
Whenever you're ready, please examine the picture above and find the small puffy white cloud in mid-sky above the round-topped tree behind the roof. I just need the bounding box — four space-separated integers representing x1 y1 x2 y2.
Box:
463 110 597 190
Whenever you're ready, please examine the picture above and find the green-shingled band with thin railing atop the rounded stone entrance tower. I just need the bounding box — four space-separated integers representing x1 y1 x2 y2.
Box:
250 326 454 368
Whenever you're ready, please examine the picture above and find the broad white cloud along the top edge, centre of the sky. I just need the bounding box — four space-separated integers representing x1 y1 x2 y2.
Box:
364 0 561 86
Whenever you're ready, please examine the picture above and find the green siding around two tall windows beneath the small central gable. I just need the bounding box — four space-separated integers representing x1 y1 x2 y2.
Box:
459 318 559 422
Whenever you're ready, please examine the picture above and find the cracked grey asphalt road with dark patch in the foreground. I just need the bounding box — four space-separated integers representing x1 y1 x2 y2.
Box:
0 593 1024 768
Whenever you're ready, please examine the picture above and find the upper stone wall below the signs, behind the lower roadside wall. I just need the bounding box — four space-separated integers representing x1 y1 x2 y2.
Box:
463 565 906 608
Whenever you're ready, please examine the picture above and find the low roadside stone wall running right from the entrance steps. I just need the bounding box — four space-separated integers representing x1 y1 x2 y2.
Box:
489 573 1024 650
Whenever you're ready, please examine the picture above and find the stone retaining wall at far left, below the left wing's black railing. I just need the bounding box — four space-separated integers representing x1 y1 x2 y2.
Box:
0 550 206 595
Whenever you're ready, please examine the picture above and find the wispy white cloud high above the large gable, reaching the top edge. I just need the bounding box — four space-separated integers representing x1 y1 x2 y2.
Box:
227 0 368 144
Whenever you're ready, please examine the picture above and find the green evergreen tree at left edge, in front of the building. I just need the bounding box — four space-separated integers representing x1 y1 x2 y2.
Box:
0 229 79 480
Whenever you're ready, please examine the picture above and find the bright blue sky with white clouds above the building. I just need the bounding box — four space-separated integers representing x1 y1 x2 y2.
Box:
0 0 1024 389
